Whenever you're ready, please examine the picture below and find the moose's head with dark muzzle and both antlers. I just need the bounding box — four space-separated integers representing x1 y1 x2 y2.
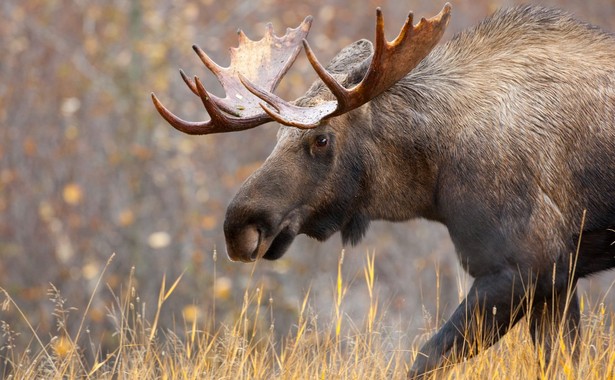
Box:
152 4 451 262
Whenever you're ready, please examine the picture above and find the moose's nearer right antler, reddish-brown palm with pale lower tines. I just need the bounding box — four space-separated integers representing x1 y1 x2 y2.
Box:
242 3 451 128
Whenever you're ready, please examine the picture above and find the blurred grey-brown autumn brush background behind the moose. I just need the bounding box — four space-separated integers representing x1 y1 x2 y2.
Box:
0 0 615 366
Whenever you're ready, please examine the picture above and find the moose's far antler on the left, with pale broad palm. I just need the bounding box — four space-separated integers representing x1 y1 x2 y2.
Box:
152 16 312 135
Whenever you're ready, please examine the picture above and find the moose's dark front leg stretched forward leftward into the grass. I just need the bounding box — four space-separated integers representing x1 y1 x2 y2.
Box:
408 270 525 379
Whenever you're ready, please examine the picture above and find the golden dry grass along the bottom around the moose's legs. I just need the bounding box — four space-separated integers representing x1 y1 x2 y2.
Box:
0 254 615 380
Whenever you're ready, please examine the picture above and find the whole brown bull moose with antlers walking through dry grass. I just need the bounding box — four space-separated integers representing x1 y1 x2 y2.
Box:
152 4 615 378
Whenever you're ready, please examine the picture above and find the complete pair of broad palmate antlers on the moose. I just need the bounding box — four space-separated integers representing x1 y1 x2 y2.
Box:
152 3 451 134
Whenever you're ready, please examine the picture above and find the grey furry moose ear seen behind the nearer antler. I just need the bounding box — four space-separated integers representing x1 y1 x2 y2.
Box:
326 39 374 88
